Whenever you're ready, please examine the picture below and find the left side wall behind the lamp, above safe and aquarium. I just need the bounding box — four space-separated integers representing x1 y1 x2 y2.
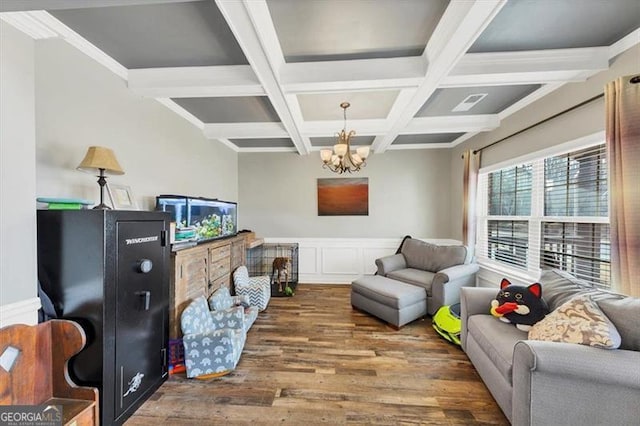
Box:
36 39 238 210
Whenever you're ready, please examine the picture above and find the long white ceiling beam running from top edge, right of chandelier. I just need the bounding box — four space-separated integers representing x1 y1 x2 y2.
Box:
372 0 506 152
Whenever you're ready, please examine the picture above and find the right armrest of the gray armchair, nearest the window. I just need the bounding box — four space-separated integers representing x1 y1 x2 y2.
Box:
428 263 480 315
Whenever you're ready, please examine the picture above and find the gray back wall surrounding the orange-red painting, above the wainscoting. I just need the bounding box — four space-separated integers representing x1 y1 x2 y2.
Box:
238 149 450 238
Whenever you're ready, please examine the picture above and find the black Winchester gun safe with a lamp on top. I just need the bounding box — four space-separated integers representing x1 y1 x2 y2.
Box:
37 210 170 425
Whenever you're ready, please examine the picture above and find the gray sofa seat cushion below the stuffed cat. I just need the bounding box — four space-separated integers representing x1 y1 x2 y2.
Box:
467 314 527 384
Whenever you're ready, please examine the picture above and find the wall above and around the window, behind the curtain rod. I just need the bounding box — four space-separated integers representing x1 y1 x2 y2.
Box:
450 45 640 243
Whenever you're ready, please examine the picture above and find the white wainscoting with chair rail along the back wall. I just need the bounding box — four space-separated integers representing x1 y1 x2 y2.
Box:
265 238 462 284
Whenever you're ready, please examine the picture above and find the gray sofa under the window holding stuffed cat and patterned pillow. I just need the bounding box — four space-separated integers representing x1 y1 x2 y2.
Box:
461 270 640 426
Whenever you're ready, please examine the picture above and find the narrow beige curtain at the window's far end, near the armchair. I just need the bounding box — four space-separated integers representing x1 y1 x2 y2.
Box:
462 150 480 258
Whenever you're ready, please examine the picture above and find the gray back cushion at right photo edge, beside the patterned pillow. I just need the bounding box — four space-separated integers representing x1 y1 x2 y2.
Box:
598 296 640 351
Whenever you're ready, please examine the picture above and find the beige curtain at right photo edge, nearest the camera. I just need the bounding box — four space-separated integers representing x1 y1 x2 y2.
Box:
605 76 640 296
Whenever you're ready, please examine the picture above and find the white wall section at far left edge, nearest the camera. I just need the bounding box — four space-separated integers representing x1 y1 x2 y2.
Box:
0 21 39 327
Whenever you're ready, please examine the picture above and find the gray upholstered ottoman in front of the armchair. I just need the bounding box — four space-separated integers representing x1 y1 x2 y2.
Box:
351 275 427 328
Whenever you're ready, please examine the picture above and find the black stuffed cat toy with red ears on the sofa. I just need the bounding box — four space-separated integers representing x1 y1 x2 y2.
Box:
491 278 549 331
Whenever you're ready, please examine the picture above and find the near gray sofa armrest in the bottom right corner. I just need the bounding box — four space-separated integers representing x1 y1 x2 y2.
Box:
512 340 640 425
